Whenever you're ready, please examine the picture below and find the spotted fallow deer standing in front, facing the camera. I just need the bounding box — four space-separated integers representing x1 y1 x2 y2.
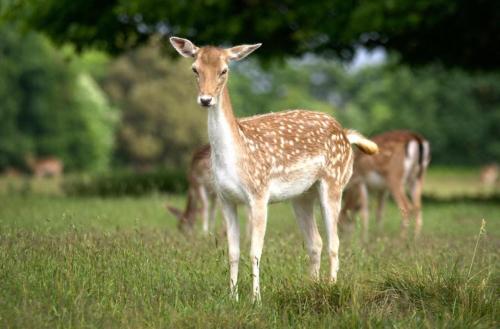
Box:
170 37 377 302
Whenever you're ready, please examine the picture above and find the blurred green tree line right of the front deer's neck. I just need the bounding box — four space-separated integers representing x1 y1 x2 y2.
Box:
230 57 500 164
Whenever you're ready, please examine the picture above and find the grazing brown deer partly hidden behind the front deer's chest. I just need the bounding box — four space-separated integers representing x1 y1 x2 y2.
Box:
167 145 217 233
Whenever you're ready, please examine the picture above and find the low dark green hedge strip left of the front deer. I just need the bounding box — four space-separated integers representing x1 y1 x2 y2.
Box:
63 169 187 197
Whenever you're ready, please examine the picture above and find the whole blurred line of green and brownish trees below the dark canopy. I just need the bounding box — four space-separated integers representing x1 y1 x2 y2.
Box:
0 25 500 171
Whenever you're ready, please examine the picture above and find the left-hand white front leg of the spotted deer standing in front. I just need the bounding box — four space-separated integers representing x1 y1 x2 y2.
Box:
221 200 240 300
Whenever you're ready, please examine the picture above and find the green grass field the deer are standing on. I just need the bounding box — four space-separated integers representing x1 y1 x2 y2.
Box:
0 170 500 328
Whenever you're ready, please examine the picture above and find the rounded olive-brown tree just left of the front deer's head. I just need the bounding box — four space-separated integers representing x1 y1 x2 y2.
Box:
103 45 206 169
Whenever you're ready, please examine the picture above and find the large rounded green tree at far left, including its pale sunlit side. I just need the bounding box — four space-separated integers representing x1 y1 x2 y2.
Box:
0 26 114 170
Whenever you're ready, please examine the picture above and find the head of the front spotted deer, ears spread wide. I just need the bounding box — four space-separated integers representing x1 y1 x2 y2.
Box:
170 37 261 107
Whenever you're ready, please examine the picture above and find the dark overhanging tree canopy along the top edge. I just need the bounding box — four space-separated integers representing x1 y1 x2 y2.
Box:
0 0 500 70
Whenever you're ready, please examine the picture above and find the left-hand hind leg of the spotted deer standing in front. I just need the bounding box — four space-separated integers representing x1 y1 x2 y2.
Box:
292 192 323 280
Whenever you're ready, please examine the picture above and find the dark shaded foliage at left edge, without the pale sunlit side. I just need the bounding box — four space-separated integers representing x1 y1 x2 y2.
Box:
0 27 75 168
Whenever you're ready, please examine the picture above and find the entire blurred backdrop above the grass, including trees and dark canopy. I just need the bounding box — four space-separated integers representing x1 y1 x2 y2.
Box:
0 0 500 196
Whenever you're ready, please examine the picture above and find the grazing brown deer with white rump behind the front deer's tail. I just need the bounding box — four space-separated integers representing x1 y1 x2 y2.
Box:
340 131 430 241
